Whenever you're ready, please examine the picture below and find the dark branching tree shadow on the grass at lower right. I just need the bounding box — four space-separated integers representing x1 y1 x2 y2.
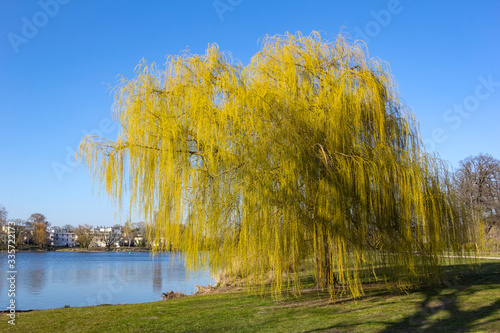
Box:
302 263 500 333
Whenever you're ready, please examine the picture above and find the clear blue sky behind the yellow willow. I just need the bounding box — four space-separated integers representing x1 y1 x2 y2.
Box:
0 0 500 225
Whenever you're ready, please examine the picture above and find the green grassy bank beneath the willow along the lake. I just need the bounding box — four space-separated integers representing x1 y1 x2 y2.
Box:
0 261 500 333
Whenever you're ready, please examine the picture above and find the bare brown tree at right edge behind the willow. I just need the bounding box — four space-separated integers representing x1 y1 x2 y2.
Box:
454 154 500 235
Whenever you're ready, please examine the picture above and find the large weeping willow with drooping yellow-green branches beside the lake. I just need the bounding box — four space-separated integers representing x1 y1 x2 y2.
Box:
79 33 476 296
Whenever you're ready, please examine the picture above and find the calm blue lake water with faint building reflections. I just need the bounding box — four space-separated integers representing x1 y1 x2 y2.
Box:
0 252 214 310
